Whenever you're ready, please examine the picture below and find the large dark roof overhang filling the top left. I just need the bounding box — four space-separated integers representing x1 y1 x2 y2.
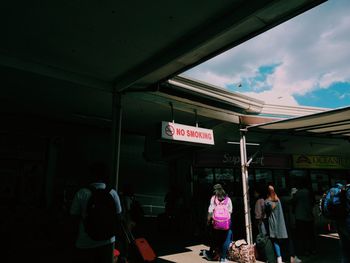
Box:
0 0 325 91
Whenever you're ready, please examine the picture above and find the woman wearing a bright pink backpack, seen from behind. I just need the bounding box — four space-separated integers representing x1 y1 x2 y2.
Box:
202 184 232 262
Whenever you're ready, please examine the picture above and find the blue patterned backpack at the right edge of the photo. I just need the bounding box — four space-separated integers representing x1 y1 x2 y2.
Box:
319 183 350 220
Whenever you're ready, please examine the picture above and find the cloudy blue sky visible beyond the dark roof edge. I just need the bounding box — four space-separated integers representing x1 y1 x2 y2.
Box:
182 0 350 109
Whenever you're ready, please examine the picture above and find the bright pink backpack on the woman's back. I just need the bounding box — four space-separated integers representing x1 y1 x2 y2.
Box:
213 197 231 230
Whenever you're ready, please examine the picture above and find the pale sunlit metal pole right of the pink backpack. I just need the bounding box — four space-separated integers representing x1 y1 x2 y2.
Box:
240 130 253 244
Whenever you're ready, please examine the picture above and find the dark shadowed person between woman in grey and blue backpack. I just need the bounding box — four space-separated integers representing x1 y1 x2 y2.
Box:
292 180 315 255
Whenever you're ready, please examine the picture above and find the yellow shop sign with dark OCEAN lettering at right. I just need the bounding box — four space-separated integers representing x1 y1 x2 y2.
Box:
293 154 350 169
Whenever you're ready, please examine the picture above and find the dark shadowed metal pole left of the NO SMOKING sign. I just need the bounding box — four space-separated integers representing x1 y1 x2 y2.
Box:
110 92 122 190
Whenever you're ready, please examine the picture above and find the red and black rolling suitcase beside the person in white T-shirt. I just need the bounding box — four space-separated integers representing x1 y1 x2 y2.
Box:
122 224 157 262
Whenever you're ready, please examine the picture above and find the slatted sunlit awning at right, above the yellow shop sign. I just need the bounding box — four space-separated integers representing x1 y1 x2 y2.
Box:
248 106 350 138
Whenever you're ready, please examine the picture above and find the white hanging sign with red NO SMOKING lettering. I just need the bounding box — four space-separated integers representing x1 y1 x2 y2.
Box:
162 121 214 145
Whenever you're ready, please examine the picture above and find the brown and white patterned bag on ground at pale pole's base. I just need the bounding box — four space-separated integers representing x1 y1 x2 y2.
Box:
228 239 256 263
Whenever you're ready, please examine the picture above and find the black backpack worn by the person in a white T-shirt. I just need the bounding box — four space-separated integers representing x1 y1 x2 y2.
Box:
83 186 117 241
